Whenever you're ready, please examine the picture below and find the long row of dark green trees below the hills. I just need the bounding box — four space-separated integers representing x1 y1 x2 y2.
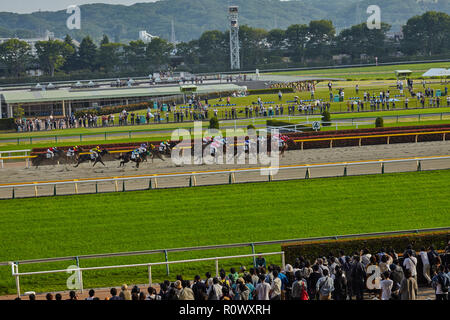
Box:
0 11 450 78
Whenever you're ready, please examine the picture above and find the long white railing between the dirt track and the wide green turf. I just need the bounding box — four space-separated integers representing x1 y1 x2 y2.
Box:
0 155 450 198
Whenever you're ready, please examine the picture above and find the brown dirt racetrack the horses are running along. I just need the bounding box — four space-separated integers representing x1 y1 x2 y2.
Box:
0 141 450 198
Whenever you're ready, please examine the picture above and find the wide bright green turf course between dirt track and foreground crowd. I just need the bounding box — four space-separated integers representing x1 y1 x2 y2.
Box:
0 171 450 294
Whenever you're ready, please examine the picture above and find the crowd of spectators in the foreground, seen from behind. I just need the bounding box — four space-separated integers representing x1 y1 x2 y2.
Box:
17 241 450 300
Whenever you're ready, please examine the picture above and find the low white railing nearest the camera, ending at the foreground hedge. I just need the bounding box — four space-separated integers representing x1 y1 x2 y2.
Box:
10 251 285 297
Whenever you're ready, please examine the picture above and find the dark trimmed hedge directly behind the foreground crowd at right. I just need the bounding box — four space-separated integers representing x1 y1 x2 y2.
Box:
281 231 450 264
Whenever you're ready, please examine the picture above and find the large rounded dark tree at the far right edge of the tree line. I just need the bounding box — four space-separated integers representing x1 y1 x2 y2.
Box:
402 11 450 56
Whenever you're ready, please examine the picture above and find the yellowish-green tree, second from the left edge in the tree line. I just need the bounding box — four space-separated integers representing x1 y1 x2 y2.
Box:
35 40 73 77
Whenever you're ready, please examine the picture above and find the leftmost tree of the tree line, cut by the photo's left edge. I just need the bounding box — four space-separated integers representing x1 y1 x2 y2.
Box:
0 39 31 78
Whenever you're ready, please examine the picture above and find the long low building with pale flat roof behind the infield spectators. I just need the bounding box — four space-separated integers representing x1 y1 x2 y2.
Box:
0 82 247 118
